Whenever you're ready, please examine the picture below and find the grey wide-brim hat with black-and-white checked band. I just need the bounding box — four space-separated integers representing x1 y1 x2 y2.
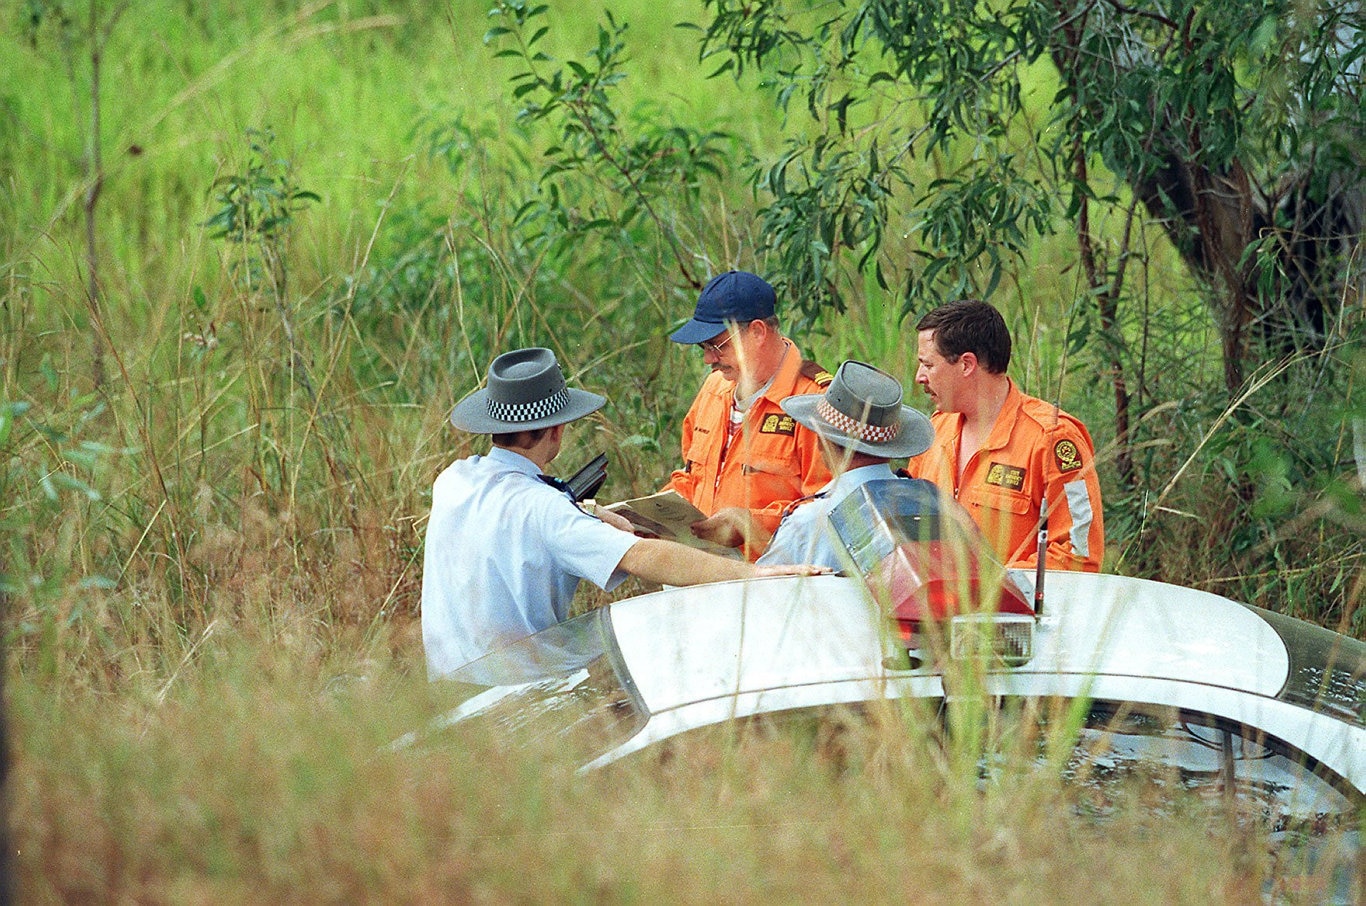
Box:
451 347 607 435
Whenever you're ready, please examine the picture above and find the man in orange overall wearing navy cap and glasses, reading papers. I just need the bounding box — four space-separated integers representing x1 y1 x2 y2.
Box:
665 271 832 560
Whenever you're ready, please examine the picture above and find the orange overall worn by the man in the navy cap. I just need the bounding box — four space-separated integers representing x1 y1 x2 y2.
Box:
665 343 832 560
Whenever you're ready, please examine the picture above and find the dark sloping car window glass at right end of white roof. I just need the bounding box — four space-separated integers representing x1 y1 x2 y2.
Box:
1251 608 1366 727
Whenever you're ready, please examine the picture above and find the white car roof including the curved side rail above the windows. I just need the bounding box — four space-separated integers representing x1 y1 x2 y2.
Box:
589 571 1366 790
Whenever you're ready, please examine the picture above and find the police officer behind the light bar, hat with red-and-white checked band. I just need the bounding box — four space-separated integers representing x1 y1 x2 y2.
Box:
758 361 934 570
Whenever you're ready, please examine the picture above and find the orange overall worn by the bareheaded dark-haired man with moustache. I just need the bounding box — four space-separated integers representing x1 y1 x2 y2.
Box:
907 381 1105 573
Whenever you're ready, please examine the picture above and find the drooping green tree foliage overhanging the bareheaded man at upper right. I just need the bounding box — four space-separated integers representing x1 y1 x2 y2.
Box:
699 0 1366 392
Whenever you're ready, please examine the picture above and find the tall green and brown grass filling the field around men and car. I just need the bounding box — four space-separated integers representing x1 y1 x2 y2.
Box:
0 0 1362 902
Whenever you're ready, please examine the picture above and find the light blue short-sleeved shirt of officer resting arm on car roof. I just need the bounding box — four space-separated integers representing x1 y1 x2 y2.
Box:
422 447 637 679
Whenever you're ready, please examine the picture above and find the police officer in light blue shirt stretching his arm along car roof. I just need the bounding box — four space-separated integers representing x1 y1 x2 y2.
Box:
422 347 825 679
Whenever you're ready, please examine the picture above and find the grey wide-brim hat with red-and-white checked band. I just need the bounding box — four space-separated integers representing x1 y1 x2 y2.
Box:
781 361 934 459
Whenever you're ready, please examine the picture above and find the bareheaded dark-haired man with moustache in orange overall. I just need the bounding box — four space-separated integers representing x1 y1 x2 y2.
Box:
907 299 1105 573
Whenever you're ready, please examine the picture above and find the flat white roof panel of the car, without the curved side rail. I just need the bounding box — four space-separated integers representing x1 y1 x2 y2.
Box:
612 573 1290 712
